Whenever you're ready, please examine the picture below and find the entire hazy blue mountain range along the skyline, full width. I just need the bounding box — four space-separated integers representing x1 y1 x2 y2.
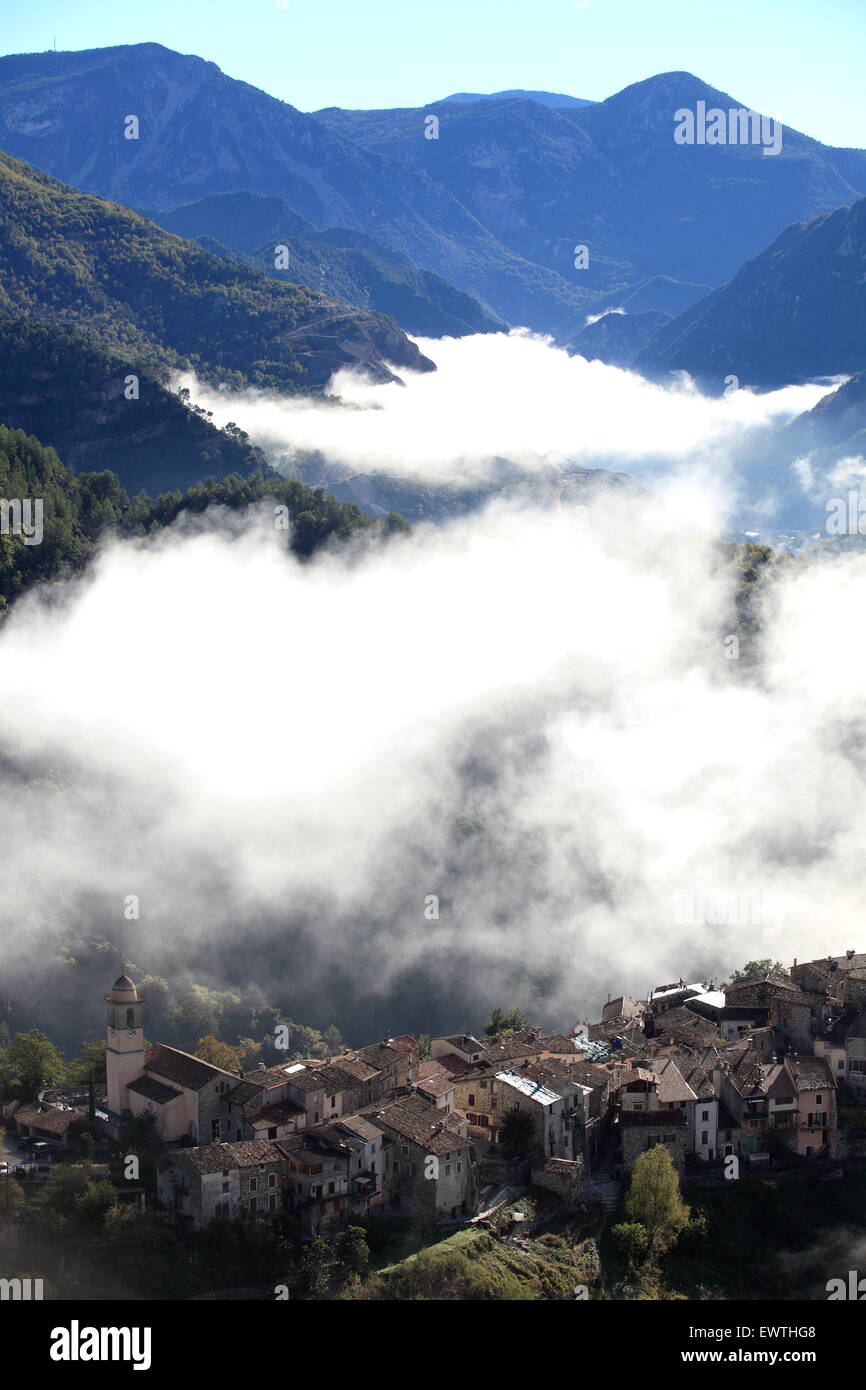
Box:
0 44 866 338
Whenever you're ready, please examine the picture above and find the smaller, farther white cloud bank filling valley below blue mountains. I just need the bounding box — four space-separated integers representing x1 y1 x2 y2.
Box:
179 329 828 487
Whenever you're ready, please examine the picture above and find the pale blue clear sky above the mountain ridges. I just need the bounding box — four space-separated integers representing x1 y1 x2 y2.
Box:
1 0 866 147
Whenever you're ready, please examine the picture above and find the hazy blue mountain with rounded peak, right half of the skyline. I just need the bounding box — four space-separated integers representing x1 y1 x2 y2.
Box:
318 72 866 298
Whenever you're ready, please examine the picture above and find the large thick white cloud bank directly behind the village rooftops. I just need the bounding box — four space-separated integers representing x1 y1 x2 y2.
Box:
0 481 866 1037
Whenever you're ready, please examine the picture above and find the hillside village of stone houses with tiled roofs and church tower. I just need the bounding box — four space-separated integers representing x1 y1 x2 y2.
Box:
6 951 866 1237
